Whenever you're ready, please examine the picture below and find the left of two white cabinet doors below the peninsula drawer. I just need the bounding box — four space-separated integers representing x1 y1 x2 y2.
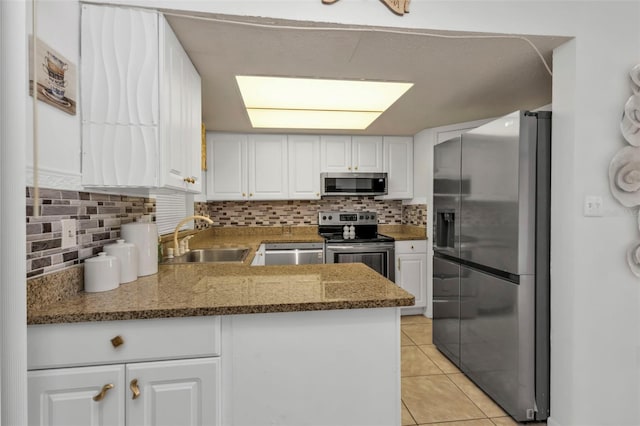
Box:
27 365 125 426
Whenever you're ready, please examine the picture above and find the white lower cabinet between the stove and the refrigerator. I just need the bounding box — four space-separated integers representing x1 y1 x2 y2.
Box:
395 240 427 309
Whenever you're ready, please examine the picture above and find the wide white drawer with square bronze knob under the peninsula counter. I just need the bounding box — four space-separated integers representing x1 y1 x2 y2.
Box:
27 317 220 370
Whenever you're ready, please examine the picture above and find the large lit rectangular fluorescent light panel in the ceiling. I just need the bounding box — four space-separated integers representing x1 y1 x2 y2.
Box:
236 76 413 129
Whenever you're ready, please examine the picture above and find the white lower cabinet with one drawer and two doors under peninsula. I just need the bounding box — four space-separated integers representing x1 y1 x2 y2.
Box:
27 317 222 426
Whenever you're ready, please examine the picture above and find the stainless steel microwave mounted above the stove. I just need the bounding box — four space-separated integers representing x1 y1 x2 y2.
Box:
320 173 387 195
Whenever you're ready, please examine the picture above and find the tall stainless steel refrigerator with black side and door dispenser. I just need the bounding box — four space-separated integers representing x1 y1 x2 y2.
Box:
433 111 551 421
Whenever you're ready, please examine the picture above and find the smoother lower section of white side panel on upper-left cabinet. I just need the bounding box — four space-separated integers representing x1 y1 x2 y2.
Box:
82 123 158 187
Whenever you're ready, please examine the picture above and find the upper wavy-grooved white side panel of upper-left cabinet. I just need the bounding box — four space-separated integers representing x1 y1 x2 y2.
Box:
81 5 159 125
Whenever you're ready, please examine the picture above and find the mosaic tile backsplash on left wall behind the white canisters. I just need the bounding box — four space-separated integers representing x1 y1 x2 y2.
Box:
26 187 155 278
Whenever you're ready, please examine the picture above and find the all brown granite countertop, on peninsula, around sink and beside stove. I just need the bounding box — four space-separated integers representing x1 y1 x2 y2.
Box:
27 225 425 324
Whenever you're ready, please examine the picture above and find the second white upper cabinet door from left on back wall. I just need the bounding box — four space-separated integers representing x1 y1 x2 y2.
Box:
248 135 289 200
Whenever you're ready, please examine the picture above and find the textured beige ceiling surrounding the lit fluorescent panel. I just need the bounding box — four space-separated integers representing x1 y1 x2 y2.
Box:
167 14 568 135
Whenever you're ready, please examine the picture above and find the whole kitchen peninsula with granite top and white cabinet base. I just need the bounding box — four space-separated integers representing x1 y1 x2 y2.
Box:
27 237 413 425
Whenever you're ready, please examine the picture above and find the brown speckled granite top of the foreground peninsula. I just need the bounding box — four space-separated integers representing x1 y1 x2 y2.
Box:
27 263 414 324
